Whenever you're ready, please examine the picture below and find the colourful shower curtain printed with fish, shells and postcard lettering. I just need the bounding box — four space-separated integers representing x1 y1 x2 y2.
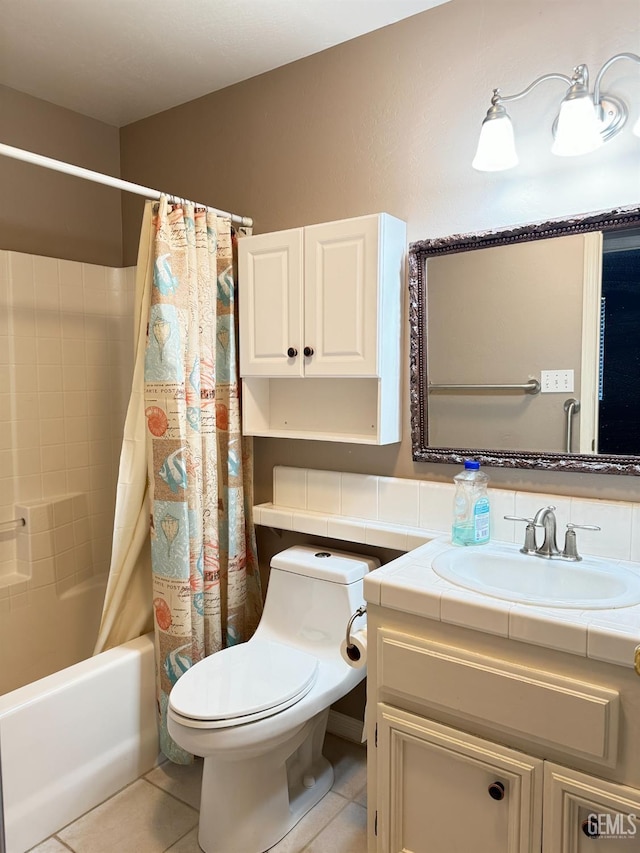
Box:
144 198 262 764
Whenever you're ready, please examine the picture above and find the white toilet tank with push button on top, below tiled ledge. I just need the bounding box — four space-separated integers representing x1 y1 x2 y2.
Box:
258 545 380 654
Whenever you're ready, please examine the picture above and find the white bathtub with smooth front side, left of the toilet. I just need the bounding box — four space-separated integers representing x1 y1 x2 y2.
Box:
0 634 159 853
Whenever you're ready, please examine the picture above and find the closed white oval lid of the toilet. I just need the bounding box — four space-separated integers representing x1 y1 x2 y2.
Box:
169 640 318 721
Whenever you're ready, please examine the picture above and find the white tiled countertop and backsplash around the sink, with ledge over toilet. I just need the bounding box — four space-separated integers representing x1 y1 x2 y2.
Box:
254 466 640 666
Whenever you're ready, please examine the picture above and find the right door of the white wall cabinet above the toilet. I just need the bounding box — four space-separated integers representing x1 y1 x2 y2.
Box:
304 216 379 376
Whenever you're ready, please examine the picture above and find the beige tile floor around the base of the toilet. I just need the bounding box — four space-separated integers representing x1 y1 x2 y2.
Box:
32 734 367 853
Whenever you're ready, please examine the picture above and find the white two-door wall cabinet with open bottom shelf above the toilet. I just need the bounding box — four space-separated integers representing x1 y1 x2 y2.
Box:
239 214 406 444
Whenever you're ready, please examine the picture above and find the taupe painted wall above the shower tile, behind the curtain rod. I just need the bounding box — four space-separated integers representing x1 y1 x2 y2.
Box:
0 86 122 266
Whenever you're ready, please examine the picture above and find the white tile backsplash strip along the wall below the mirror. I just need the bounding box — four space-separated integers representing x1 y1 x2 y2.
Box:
268 466 640 562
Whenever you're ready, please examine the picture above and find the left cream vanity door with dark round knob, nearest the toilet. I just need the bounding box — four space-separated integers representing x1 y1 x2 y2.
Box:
376 704 543 853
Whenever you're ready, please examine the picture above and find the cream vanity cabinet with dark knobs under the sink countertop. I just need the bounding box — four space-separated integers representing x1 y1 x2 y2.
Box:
367 602 640 853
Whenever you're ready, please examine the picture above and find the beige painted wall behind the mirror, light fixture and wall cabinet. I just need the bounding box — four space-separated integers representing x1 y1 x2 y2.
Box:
121 0 640 500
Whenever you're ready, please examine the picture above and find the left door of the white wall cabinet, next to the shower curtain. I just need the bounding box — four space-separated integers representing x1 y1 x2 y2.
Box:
238 228 304 376
